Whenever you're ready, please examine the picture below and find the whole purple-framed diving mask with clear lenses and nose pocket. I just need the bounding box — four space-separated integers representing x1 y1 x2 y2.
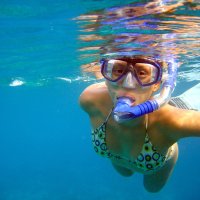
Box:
101 58 162 88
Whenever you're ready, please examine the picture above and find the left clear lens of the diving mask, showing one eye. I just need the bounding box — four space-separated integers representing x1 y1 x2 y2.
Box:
102 60 127 81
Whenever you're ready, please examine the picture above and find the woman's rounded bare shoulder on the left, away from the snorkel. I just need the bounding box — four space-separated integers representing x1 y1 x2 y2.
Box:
79 82 110 113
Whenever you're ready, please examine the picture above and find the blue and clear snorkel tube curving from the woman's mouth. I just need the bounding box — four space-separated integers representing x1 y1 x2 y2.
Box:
113 59 178 123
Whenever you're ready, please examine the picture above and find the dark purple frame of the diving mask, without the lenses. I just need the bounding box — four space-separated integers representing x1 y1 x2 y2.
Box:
100 58 162 86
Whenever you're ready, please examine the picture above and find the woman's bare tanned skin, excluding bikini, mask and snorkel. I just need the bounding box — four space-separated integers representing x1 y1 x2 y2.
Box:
80 77 200 192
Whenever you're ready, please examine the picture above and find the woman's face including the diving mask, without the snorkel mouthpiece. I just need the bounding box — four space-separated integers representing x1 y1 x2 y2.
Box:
101 58 162 105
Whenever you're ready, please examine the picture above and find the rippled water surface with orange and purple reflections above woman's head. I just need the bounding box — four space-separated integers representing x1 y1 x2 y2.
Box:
74 0 200 80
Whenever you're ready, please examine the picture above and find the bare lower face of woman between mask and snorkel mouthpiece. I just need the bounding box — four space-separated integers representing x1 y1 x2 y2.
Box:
106 80 160 105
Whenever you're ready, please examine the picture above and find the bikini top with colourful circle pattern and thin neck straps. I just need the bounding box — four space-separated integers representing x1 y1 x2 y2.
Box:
92 111 171 172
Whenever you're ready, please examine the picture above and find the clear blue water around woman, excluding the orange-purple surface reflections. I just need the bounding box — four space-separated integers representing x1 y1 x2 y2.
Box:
0 0 200 200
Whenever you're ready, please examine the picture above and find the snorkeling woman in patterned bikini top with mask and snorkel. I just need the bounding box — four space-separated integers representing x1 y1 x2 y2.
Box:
80 56 200 192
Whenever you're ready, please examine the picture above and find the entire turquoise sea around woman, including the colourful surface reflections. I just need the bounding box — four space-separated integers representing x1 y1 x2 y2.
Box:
0 0 200 200
